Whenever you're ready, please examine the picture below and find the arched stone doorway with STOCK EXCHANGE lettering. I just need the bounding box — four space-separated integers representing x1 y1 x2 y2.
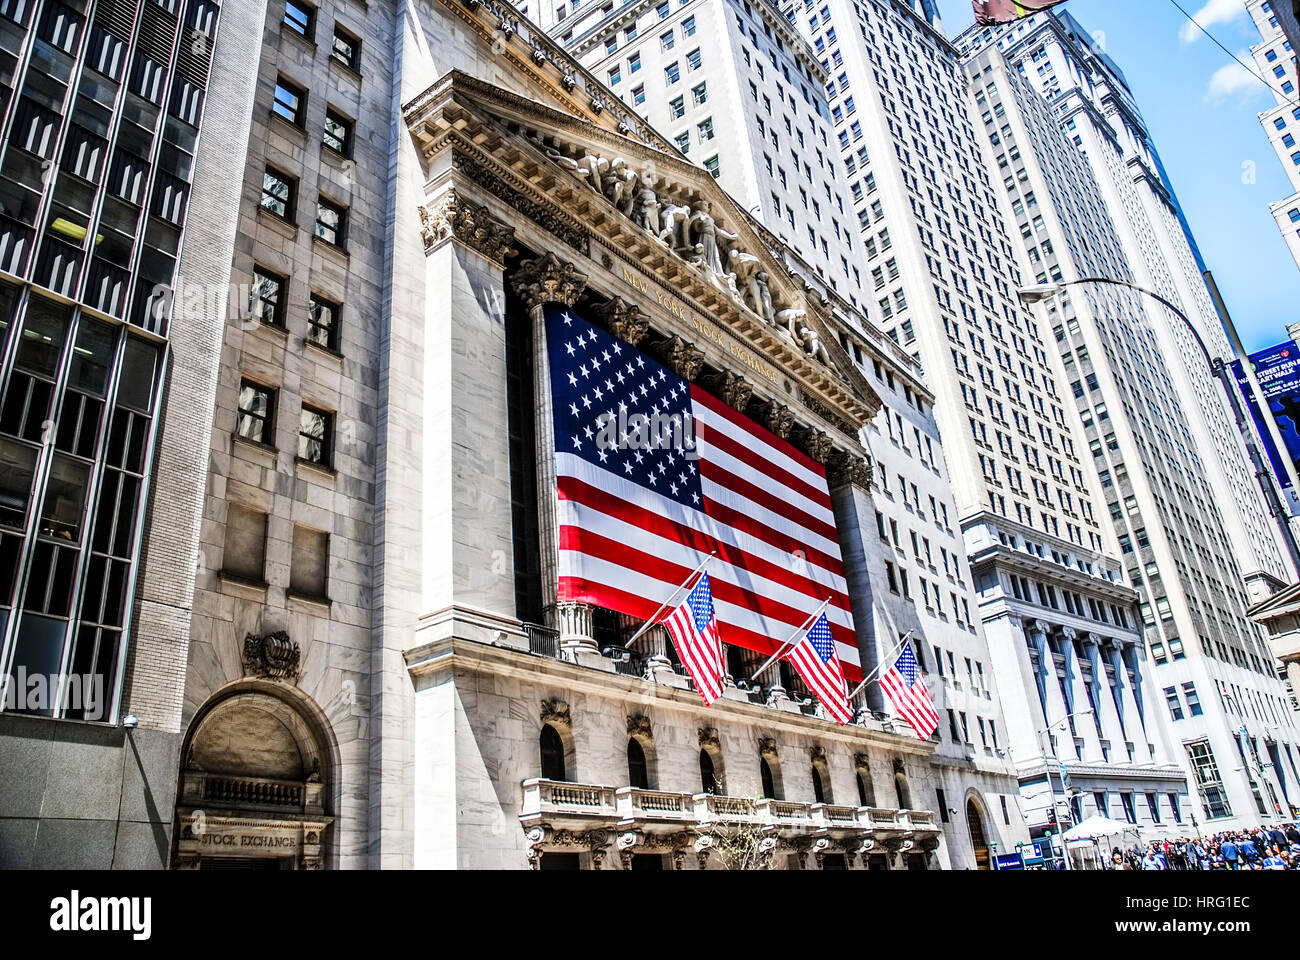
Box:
174 684 334 870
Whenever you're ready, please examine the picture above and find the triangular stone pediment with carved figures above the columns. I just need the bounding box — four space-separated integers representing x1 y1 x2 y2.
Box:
406 72 880 429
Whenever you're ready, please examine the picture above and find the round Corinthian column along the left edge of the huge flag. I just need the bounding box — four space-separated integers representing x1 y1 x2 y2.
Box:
511 251 601 658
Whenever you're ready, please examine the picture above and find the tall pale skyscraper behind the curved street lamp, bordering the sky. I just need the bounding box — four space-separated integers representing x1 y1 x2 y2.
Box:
962 16 1300 826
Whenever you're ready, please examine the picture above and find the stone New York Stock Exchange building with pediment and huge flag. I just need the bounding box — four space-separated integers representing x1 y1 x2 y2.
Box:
0 0 1024 870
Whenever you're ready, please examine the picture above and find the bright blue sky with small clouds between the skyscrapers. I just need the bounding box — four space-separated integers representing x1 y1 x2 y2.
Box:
939 0 1300 351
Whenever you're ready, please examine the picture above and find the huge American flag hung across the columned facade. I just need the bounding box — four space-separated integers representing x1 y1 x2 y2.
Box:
546 304 862 679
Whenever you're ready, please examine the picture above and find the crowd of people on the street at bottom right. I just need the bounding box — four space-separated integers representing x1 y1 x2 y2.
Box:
1109 823 1300 870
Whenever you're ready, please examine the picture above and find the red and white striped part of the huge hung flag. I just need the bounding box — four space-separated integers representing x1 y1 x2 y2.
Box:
555 386 862 682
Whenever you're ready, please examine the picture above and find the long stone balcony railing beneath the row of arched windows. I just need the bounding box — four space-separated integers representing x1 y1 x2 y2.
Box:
520 778 939 839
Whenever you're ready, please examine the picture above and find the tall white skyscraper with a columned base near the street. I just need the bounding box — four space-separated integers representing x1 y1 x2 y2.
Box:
769 0 1186 836
